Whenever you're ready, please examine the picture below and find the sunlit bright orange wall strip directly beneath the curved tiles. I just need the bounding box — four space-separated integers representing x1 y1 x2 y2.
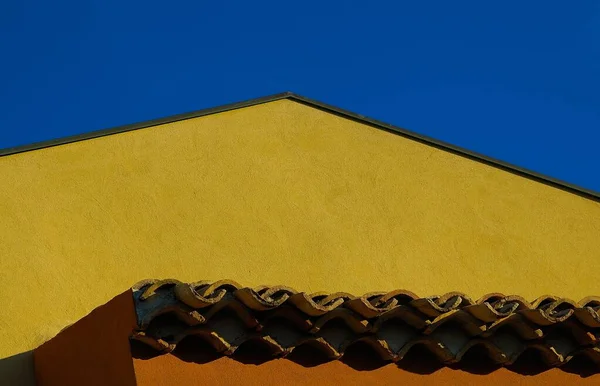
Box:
134 355 600 386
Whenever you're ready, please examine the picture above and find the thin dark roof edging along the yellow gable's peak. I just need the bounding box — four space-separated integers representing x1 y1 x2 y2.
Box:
0 92 600 202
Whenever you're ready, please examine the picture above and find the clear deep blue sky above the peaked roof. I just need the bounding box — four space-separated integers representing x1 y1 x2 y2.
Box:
0 0 600 191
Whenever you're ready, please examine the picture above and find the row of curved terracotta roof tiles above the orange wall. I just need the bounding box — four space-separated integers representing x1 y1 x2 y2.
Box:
132 279 600 366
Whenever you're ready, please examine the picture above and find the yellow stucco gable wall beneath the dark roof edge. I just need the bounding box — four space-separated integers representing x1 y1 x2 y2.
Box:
0 100 600 358
